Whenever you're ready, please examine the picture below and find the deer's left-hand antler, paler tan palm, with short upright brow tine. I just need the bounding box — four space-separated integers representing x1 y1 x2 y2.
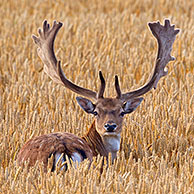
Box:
32 20 105 100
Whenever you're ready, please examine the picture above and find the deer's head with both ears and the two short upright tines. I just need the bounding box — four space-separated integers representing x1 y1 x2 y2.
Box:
76 71 143 141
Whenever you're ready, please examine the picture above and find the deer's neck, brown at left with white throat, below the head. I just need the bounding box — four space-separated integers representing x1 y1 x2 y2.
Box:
83 121 120 160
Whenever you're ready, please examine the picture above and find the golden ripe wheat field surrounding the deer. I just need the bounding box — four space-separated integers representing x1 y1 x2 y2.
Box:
0 0 194 194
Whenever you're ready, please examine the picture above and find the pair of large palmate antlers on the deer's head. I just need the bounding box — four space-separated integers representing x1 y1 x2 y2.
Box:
32 19 179 102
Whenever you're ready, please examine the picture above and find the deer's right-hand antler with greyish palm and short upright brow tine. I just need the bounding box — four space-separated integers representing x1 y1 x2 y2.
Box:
118 19 179 101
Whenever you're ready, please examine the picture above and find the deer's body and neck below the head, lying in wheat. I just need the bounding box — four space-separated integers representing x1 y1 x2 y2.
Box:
17 122 120 171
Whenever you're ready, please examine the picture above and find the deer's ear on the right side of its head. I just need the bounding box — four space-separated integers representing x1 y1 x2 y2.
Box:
123 98 143 114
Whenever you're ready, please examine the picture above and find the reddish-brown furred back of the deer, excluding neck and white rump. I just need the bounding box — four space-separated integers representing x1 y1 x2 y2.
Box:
17 133 93 170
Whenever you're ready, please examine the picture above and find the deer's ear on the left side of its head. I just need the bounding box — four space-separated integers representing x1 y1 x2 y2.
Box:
76 97 95 113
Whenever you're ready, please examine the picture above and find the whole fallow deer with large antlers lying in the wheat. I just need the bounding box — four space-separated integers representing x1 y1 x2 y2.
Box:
17 19 179 170
